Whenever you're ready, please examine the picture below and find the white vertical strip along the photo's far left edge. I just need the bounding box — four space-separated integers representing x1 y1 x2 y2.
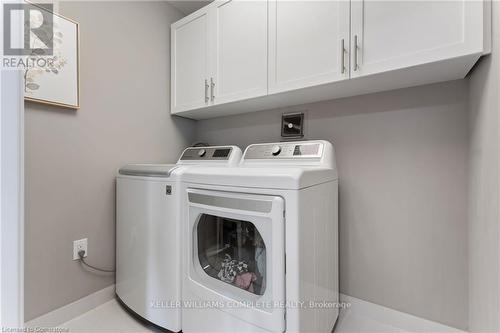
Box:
0 70 24 327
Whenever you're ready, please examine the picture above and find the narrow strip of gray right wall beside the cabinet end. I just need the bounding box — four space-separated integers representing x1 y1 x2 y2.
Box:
469 1 500 332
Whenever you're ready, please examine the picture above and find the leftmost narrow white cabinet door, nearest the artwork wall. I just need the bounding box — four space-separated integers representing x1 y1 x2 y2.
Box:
171 11 209 113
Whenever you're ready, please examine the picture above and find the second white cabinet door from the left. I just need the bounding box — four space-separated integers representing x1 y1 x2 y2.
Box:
210 0 268 104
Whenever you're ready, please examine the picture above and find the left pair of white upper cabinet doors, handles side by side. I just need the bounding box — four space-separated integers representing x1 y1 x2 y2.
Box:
171 0 268 113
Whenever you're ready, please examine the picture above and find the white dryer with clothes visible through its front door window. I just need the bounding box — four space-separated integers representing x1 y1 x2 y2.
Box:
182 141 339 333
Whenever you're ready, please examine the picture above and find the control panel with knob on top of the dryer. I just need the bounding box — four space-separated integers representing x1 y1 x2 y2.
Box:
243 142 323 160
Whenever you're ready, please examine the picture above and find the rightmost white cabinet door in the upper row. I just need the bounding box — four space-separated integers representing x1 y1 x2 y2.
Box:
351 0 483 77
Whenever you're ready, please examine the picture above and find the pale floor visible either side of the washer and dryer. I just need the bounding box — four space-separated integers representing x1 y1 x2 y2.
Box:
60 300 405 333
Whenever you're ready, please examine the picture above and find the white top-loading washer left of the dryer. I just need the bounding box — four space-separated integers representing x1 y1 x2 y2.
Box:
116 146 241 332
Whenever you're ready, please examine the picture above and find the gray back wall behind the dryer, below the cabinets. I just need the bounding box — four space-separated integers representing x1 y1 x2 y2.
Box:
197 80 468 329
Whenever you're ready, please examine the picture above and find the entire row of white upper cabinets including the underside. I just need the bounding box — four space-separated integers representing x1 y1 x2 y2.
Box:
171 0 491 119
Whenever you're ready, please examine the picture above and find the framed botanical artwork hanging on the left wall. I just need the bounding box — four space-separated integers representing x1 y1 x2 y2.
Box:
24 2 80 109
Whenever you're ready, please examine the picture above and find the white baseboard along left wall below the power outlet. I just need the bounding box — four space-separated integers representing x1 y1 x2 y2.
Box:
24 284 115 327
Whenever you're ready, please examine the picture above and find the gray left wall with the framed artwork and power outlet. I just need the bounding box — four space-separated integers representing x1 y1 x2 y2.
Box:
25 2 194 320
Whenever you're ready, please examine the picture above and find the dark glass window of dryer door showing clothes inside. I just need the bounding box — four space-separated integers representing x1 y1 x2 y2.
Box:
197 214 266 295
